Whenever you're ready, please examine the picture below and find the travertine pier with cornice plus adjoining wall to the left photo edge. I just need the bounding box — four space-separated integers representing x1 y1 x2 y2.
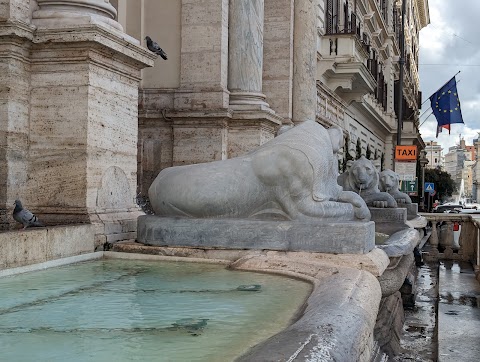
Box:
0 0 155 243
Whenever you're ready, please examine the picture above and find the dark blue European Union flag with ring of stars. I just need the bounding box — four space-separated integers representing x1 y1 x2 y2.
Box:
430 77 463 137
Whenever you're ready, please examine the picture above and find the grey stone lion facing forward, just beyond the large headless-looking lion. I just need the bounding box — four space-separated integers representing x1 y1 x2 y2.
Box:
338 156 397 208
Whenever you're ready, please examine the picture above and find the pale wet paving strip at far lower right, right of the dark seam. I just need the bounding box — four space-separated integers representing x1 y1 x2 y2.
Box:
438 261 480 362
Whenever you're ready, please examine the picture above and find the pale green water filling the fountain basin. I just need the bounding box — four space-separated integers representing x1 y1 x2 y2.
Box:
0 260 311 362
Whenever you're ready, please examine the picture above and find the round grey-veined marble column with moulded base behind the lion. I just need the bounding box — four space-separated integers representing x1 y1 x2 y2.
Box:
228 0 268 110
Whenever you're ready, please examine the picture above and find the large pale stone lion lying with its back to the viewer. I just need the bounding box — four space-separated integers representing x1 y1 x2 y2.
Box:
148 121 370 221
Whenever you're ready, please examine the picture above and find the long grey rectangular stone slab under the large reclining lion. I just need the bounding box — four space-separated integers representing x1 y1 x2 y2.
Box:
138 215 375 254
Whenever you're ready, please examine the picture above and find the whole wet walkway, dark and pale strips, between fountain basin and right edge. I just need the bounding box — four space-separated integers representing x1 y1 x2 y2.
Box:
394 261 480 362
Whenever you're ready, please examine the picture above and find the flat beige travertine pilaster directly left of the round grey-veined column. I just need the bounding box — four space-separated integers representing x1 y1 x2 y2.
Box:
174 0 229 110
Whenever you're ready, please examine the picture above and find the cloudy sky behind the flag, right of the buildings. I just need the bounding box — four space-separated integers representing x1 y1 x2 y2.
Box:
419 0 480 154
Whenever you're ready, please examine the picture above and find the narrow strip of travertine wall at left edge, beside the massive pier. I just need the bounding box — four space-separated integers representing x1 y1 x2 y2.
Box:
0 0 33 230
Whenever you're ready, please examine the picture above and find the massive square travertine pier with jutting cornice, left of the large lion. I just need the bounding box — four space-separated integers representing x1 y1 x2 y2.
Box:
25 0 155 244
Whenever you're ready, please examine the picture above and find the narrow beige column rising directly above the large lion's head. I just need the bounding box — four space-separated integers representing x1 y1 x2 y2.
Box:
292 0 317 124
